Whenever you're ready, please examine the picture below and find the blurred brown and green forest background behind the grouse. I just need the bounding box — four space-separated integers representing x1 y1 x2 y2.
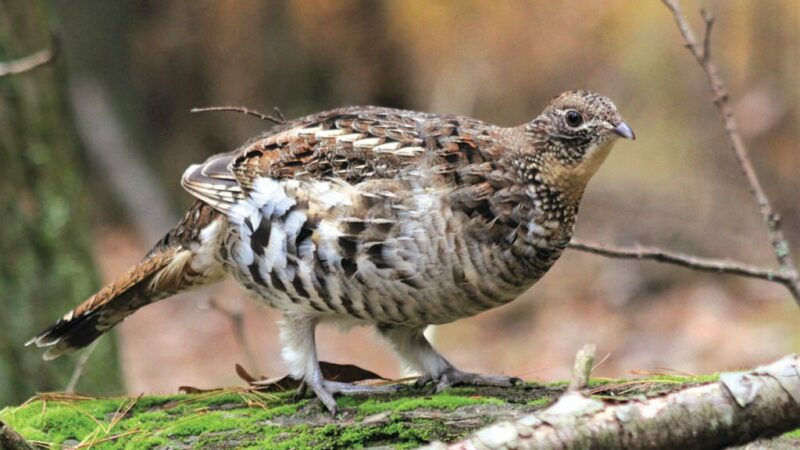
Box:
0 0 800 406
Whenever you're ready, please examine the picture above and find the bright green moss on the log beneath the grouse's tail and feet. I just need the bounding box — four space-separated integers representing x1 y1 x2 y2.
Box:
0 388 520 450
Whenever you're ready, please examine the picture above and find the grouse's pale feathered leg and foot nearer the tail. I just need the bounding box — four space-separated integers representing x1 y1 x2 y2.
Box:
281 317 400 415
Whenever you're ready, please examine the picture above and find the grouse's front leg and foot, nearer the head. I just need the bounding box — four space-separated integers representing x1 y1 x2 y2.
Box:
378 326 522 392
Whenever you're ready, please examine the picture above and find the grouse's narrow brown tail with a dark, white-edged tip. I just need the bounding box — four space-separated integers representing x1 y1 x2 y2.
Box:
25 245 215 360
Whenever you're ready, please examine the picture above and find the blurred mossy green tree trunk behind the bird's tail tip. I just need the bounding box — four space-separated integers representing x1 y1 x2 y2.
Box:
0 0 120 406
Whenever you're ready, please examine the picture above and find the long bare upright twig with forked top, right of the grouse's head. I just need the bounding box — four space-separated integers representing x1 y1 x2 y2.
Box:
661 0 800 305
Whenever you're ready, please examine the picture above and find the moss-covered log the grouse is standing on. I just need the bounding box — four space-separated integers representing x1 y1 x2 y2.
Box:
0 358 800 449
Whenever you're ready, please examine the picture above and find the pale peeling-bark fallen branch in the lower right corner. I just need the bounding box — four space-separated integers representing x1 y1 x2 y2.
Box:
426 355 800 450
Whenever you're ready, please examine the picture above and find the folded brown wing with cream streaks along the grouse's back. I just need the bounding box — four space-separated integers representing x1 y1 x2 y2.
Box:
181 107 496 215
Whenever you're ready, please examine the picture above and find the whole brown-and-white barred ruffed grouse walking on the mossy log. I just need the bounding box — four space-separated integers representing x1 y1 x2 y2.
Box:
29 91 634 411
